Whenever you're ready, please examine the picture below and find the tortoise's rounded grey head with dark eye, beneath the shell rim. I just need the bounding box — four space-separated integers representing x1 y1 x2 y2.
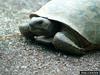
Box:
29 17 51 36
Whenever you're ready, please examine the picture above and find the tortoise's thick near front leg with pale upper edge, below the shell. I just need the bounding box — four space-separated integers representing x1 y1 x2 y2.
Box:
52 32 85 55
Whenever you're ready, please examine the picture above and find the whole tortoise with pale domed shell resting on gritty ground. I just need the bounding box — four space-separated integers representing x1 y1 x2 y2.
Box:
19 0 100 54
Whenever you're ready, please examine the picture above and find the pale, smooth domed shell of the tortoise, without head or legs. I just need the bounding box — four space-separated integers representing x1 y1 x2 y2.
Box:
30 0 100 45
